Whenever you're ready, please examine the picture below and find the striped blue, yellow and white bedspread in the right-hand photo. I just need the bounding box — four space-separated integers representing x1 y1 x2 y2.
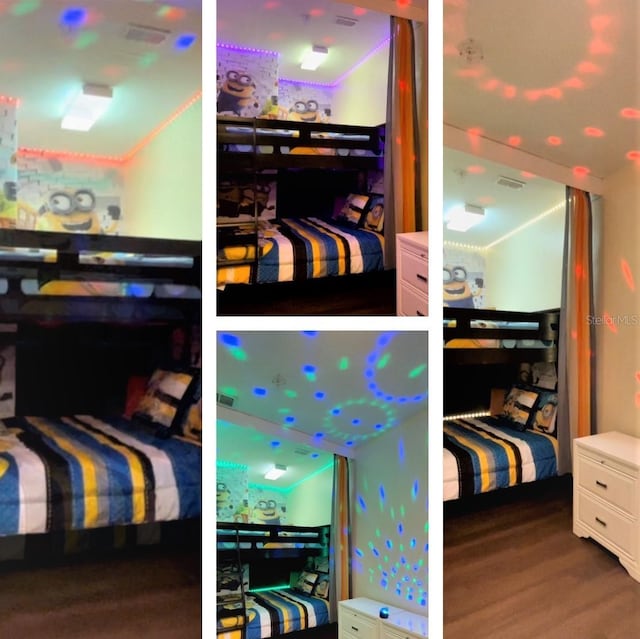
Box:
442 417 558 501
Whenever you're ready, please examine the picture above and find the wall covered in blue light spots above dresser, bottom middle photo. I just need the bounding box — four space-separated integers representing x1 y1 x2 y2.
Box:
352 410 428 615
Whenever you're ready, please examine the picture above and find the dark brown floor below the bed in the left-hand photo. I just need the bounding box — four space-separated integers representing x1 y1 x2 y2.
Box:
0 546 202 639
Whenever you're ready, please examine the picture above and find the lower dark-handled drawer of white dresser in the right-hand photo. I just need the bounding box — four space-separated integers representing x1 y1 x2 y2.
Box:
577 492 637 557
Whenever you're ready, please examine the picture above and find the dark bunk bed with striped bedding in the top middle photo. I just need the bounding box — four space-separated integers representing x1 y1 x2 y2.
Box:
217 116 384 289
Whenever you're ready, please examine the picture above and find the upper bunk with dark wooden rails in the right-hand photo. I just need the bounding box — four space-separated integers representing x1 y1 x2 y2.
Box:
443 307 560 365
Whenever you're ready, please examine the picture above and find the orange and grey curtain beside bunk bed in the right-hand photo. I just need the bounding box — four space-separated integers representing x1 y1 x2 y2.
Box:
558 186 595 472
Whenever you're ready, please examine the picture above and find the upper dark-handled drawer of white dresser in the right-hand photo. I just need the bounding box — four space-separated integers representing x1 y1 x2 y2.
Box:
577 455 637 517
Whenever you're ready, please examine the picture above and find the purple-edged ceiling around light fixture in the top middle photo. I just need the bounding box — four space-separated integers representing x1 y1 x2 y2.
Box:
216 0 426 84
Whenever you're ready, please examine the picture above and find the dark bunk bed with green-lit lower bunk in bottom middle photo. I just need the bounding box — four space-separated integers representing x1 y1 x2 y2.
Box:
217 522 329 639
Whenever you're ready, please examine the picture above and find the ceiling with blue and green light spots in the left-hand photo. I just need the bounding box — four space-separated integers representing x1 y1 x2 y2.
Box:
0 0 202 157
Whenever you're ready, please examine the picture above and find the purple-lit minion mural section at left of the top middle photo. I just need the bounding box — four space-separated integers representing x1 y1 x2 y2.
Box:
216 45 278 118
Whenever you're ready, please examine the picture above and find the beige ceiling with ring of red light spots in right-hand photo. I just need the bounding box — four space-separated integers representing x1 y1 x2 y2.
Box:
443 0 640 178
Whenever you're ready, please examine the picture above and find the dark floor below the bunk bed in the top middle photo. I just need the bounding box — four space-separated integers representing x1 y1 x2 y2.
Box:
217 270 396 316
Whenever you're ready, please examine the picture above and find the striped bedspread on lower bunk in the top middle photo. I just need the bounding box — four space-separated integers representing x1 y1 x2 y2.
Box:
217 217 384 287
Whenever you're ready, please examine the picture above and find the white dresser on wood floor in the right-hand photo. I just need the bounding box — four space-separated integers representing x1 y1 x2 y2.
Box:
573 432 640 581
